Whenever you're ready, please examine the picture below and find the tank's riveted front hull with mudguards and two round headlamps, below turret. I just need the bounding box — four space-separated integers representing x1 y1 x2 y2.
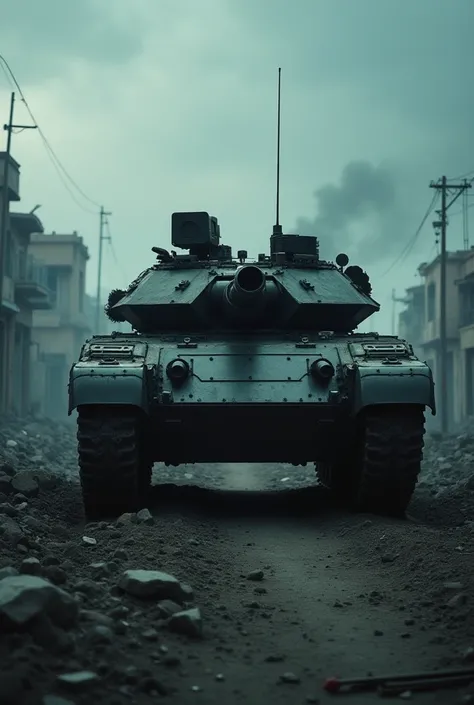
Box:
69 333 434 465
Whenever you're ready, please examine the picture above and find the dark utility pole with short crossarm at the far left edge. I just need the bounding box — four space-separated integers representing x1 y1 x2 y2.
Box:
0 93 37 409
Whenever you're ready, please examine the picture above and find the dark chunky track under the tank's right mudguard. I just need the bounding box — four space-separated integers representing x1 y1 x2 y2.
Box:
316 406 425 516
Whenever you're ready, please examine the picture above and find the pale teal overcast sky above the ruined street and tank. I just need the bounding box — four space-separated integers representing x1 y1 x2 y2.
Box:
0 0 474 330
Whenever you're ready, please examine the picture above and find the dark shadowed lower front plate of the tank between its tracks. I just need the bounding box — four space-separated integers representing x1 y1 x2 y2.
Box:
152 403 350 465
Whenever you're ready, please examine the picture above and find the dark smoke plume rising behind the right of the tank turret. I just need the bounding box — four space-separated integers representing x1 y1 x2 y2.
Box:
296 161 400 263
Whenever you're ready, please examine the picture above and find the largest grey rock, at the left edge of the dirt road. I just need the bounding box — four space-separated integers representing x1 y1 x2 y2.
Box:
0 575 78 629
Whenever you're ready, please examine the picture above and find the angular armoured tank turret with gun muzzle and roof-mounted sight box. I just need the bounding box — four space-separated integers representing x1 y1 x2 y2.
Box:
106 211 379 333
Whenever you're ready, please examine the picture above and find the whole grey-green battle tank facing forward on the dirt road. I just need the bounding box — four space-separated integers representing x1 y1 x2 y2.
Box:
69 212 436 518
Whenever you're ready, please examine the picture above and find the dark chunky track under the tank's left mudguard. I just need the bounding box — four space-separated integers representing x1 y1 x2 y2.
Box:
77 406 152 519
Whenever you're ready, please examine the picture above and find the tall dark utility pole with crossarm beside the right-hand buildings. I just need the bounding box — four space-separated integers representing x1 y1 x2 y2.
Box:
430 176 471 433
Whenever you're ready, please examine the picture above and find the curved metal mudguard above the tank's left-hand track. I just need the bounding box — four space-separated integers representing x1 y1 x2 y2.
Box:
68 362 148 414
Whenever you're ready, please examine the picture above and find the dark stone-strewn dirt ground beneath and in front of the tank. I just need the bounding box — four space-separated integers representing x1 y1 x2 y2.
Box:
0 418 474 705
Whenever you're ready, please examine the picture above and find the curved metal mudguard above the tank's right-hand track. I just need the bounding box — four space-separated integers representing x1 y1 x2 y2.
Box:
354 361 436 416
